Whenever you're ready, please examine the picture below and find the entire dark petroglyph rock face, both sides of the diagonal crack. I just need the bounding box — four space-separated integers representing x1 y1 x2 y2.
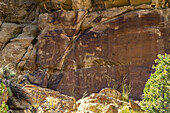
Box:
15 6 170 99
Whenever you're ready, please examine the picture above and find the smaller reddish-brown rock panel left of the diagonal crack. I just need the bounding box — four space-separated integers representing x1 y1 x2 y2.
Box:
36 10 86 70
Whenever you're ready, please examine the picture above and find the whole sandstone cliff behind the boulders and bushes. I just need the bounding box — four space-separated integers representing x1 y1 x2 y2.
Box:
0 0 170 103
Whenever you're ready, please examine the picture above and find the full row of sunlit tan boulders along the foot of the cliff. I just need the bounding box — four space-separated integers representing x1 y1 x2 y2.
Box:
8 86 141 113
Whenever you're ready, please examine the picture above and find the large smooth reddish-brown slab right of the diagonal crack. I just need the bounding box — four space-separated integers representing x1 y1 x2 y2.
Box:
56 9 170 99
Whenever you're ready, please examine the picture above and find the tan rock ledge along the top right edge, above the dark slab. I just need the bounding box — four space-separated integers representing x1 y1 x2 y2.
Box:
72 0 169 11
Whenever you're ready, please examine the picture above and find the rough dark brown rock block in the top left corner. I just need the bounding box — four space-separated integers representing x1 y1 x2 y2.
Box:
0 0 36 23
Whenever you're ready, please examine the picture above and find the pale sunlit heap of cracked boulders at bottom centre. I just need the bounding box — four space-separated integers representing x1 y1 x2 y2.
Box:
76 88 129 113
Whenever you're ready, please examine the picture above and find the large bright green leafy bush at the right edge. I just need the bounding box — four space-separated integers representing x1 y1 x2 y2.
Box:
142 54 170 113
